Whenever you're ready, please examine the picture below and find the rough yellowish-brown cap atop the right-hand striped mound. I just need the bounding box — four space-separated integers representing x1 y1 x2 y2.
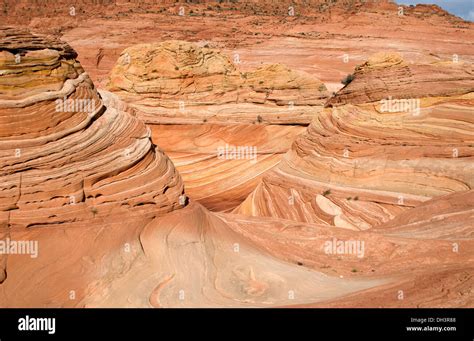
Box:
326 53 474 106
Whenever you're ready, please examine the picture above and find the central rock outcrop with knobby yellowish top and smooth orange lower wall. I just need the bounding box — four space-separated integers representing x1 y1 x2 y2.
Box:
104 41 328 210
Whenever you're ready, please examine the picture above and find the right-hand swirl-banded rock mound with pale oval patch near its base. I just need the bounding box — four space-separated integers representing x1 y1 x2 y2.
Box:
236 57 474 229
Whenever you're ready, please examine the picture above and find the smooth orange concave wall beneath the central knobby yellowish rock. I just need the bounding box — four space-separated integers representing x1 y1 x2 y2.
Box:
150 124 305 211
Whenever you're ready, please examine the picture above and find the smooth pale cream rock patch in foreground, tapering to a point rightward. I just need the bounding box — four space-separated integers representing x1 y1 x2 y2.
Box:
81 203 385 308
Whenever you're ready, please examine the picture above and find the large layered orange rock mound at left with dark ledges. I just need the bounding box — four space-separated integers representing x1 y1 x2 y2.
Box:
0 29 183 228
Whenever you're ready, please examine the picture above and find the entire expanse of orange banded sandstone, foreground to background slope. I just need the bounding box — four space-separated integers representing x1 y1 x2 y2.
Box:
0 0 474 307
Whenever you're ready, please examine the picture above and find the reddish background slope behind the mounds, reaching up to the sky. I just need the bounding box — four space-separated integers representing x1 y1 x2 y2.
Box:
0 0 473 91
